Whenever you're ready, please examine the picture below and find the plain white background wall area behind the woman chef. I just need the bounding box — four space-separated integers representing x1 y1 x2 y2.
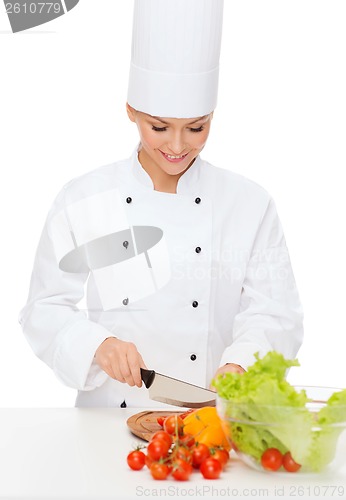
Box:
0 0 346 407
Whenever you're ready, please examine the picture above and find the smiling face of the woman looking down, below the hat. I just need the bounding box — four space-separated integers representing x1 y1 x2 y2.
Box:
126 104 213 179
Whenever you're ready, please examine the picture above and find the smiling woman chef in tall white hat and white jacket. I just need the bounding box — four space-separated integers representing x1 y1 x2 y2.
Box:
21 0 302 407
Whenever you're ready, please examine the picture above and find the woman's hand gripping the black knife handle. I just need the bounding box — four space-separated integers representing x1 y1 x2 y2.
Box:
95 337 146 387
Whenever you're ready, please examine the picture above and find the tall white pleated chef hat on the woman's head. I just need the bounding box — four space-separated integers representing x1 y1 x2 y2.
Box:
128 0 223 118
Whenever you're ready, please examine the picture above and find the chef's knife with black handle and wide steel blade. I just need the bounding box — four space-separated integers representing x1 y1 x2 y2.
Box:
141 368 216 408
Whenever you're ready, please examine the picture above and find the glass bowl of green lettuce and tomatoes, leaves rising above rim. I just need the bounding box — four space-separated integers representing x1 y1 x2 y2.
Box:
213 351 346 472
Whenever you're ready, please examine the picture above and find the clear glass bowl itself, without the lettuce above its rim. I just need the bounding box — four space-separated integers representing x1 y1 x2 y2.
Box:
216 386 346 474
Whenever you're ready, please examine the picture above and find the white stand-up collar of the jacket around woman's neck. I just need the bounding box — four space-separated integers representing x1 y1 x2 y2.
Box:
131 143 202 194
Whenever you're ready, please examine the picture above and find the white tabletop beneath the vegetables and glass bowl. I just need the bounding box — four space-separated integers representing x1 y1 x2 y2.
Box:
0 408 346 500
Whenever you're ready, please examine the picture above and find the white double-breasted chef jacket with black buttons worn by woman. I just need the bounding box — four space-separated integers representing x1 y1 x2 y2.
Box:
20 148 303 407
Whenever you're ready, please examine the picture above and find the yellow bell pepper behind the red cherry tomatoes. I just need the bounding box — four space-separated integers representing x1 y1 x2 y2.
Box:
184 406 231 451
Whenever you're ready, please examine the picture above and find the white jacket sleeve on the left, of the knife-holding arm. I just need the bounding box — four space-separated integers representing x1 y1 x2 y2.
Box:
19 199 114 390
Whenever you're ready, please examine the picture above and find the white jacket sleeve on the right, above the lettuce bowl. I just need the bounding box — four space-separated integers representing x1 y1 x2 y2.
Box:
220 200 303 369
